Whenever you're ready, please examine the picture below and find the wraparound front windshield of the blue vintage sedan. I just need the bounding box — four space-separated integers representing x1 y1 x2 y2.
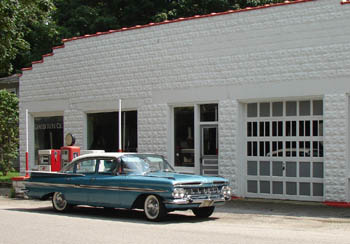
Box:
121 154 174 174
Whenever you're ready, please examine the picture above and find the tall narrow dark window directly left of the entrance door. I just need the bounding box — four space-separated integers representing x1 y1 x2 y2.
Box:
174 107 194 167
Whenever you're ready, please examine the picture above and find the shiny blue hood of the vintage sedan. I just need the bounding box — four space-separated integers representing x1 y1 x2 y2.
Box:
145 172 228 185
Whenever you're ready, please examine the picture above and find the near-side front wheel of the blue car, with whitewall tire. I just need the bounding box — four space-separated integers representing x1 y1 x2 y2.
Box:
144 195 167 221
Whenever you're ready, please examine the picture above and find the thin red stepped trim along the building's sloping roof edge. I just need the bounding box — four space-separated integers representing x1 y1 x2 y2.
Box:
22 0 314 74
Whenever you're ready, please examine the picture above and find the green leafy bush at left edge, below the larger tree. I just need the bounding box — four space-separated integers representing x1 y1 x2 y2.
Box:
0 89 19 175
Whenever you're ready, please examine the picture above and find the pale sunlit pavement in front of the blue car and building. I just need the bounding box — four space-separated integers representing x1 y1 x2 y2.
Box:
0 192 350 244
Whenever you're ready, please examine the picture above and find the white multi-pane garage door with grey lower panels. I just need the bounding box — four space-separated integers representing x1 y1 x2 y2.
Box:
244 100 324 201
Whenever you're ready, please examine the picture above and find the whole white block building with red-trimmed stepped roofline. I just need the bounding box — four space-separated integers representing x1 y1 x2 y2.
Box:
20 0 350 202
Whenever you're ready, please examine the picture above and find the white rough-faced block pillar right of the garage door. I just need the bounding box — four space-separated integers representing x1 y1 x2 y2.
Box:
324 93 349 201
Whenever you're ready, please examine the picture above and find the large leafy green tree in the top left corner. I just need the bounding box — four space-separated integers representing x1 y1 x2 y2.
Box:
0 0 58 77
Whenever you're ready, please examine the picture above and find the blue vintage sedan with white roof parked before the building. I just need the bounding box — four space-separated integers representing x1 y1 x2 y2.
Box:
26 153 231 221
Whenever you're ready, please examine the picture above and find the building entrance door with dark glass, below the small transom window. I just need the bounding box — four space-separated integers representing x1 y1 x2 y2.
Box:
200 125 219 175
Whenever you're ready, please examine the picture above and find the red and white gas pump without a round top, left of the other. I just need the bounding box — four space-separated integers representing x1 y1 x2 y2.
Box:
38 149 61 172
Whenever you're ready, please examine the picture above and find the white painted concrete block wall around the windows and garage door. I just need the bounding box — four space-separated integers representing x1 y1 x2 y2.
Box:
20 0 350 199
